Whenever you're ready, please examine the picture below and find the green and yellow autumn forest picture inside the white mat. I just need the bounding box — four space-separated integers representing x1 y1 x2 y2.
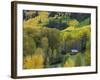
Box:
23 10 91 69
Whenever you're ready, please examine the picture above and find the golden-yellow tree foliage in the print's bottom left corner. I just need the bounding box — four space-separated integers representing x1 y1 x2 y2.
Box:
24 48 44 69
